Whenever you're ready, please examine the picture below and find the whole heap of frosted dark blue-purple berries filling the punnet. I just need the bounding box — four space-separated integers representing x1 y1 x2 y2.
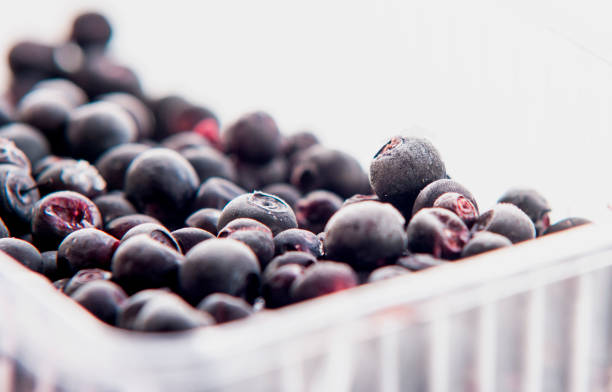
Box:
0 12 587 332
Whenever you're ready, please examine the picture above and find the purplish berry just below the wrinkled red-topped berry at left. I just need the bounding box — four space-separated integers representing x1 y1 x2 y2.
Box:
57 228 119 276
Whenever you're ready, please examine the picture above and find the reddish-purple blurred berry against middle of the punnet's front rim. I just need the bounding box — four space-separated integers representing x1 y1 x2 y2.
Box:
291 261 358 302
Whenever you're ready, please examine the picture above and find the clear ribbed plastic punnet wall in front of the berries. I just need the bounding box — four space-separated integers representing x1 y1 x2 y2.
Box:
0 225 612 392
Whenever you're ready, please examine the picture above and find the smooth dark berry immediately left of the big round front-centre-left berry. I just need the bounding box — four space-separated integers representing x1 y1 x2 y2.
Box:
111 234 184 293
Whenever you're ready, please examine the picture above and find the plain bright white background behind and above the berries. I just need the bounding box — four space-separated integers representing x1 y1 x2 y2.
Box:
0 0 612 224
